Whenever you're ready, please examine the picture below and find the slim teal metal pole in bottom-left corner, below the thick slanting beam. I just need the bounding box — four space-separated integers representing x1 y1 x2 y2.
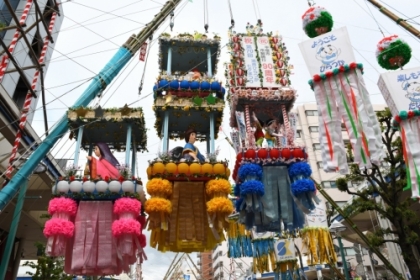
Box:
0 181 28 279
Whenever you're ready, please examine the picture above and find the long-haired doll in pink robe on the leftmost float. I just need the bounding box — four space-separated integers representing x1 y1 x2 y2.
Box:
87 142 120 179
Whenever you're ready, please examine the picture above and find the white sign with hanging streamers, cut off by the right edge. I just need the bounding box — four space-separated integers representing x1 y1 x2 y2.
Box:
378 68 420 199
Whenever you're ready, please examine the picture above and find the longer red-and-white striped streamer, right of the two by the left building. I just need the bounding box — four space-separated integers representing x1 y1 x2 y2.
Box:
5 12 57 179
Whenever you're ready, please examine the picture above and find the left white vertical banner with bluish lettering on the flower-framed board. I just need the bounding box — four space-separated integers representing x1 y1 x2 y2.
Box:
242 37 261 87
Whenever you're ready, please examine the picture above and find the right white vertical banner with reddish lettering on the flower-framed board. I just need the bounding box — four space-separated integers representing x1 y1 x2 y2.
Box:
257 37 279 88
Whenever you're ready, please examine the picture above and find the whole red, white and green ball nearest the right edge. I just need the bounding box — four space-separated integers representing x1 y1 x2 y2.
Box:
376 35 411 70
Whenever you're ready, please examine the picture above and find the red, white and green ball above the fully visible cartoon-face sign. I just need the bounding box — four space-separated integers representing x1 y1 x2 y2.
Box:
302 7 334 38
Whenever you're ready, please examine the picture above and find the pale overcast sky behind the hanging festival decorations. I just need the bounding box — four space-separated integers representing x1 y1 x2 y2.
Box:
25 0 420 280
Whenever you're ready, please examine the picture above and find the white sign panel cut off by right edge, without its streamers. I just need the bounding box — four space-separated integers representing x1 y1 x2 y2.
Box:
378 67 420 116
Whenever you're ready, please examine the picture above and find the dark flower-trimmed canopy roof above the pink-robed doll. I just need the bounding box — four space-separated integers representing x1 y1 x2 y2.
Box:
67 106 147 152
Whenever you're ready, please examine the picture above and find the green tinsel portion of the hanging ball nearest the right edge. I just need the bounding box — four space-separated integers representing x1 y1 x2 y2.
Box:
377 40 411 70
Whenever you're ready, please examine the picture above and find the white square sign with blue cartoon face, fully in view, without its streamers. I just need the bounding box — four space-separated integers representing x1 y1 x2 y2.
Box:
299 27 356 76
